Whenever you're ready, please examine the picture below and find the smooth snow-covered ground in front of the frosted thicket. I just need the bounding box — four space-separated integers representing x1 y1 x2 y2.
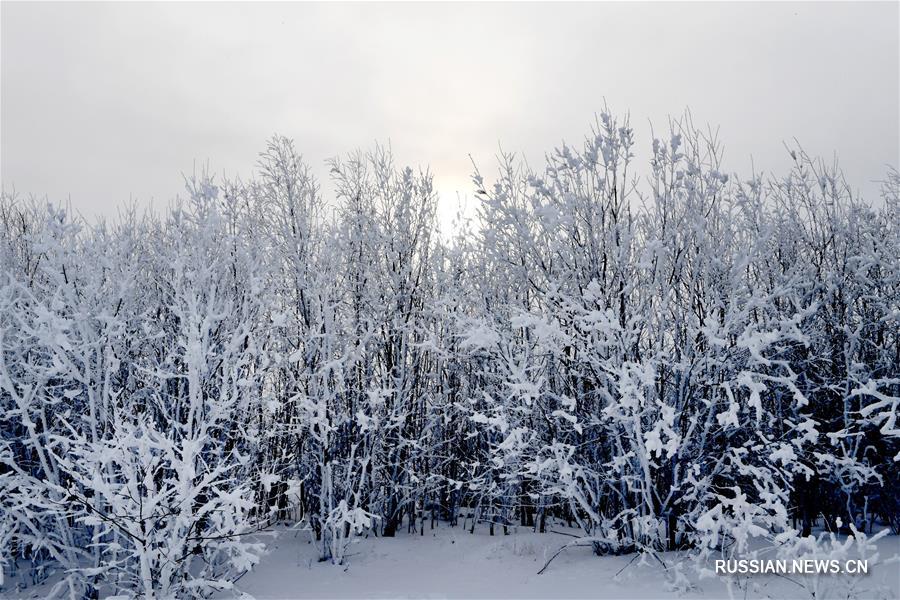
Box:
227 525 900 599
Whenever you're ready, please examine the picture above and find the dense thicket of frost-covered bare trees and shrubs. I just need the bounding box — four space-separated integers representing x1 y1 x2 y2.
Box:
0 114 900 597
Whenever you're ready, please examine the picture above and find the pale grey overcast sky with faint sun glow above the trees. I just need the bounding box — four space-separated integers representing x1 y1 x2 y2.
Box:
0 2 900 227
